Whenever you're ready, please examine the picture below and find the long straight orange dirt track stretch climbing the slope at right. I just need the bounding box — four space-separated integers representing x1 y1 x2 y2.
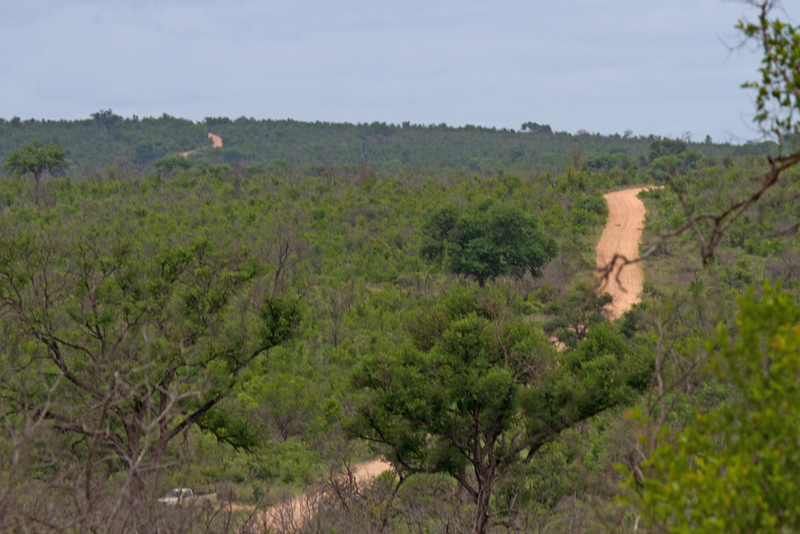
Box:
597 187 647 320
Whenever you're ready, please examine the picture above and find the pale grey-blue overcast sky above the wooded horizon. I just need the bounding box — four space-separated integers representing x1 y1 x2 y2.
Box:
0 0 800 141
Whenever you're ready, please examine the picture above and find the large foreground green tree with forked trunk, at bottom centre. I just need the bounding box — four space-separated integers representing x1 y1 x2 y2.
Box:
349 289 651 534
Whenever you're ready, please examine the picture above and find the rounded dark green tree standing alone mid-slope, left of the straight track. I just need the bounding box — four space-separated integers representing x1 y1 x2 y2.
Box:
421 201 558 287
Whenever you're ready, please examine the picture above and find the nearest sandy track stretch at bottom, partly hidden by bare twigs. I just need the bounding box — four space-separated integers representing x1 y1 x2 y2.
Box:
248 460 392 532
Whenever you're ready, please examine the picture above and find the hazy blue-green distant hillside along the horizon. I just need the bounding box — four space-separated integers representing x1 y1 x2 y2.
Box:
0 110 774 175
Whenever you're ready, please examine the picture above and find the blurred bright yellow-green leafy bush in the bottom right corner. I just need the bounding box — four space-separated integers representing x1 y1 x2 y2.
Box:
628 287 800 534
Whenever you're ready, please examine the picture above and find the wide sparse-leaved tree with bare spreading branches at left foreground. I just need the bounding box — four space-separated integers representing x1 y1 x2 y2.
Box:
0 228 299 498
